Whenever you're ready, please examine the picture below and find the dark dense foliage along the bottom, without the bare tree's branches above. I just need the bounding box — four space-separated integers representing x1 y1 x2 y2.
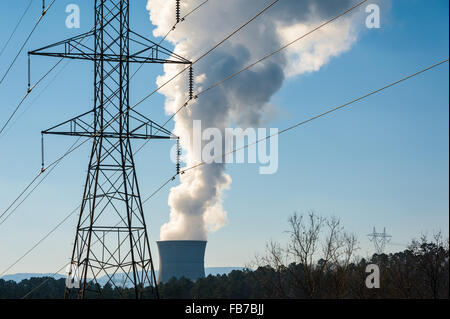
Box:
0 241 449 299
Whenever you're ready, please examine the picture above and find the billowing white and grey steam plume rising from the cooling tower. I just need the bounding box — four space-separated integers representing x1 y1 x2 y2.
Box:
147 0 364 240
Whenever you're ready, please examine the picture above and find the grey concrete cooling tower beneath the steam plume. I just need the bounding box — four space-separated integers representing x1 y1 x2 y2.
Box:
157 240 206 283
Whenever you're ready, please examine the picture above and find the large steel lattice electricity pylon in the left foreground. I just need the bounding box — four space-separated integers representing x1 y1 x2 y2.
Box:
29 0 191 298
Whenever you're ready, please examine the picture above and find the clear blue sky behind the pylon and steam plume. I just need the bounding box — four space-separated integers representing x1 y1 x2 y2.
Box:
0 0 449 273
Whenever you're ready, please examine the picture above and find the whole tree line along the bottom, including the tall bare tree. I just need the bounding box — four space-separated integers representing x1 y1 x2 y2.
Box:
0 213 449 299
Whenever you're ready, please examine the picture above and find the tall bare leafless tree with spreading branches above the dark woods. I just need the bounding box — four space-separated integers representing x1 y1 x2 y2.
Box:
257 212 358 298
